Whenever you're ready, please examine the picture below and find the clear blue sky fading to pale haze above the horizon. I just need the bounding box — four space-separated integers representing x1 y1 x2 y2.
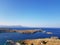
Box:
0 0 60 27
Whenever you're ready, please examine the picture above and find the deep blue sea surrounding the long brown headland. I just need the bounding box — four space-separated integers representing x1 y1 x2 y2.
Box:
0 28 60 45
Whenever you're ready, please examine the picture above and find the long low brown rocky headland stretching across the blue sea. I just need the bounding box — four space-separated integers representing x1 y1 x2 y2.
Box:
0 29 43 34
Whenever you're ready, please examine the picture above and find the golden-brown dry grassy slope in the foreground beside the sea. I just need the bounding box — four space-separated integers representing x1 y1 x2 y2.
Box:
23 38 60 45
